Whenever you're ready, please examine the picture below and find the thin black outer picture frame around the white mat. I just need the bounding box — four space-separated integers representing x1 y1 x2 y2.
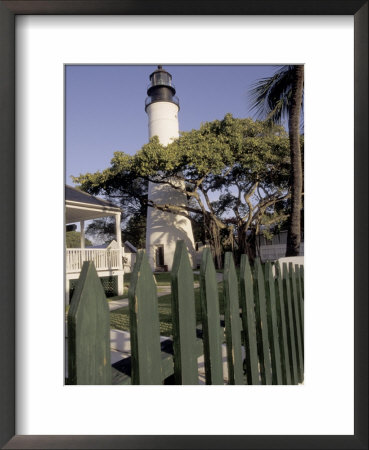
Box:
0 0 369 449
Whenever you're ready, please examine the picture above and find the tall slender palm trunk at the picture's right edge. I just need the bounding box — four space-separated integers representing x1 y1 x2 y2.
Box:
286 65 304 256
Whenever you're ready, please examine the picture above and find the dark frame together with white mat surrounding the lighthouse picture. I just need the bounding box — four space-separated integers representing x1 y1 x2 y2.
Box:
0 1 368 449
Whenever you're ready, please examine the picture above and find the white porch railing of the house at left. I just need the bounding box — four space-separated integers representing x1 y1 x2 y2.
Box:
65 248 122 273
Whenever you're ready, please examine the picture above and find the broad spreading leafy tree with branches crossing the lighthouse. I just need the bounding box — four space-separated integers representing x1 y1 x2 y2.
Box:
74 114 289 268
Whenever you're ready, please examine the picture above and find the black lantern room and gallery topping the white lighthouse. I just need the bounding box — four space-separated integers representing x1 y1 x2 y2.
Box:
145 66 179 110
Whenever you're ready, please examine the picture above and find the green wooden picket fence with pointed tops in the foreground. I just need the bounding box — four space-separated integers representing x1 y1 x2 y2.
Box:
67 241 304 385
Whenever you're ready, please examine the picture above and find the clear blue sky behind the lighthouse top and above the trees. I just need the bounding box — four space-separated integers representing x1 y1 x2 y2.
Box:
65 62 279 185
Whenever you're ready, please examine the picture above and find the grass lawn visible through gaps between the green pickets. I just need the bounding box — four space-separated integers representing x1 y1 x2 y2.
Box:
110 283 224 336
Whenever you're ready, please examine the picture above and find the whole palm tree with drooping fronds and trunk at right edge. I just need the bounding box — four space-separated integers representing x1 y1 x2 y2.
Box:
251 65 304 256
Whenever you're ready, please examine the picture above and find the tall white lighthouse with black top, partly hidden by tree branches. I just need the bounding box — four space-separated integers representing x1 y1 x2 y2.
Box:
145 66 195 270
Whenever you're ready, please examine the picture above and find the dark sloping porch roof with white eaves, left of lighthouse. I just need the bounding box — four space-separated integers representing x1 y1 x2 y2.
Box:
65 185 121 224
